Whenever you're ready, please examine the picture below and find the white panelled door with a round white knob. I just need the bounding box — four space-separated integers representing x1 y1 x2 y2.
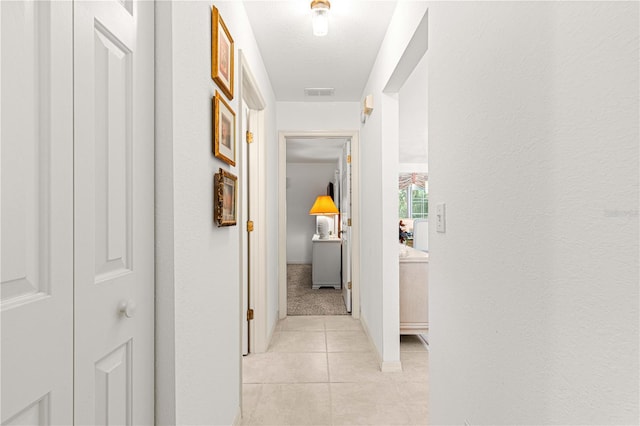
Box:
74 0 154 425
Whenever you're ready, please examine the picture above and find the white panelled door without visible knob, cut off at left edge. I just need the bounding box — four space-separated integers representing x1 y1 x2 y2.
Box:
0 1 73 425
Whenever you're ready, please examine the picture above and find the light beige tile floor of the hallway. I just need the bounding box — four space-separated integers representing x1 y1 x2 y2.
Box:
242 315 429 425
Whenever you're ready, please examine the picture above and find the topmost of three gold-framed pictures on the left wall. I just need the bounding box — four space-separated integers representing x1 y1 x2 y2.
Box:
211 6 233 100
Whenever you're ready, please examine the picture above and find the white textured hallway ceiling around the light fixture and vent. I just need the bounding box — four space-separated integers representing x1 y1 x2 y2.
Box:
244 0 396 102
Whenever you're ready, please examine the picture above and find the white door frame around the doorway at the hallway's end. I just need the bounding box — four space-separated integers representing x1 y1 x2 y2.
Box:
278 130 360 319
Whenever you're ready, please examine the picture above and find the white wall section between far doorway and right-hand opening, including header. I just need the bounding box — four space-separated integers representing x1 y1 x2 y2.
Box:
360 2 427 369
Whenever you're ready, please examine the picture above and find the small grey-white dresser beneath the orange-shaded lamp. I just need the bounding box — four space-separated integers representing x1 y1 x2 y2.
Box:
311 234 342 290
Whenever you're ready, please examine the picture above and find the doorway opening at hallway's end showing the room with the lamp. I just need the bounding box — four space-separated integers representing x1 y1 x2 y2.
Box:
286 138 351 316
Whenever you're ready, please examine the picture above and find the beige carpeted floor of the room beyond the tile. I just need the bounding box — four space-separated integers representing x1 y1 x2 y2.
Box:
287 265 347 315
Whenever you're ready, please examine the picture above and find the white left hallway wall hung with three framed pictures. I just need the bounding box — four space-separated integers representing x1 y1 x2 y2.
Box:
156 1 277 425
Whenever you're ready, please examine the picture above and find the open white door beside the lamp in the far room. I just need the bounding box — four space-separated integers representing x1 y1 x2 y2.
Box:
340 141 351 312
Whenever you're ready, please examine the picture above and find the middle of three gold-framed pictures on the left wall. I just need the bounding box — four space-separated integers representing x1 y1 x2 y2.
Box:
213 91 236 166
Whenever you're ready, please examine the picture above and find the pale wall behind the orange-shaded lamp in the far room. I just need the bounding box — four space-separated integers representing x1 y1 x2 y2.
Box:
287 163 338 264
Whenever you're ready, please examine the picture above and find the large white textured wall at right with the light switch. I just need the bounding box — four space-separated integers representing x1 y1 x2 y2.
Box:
428 2 639 424
